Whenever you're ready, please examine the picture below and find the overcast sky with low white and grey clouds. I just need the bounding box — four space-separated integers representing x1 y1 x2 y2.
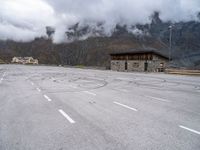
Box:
0 0 200 42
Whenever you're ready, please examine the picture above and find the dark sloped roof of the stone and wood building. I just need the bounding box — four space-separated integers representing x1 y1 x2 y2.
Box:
110 49 169 59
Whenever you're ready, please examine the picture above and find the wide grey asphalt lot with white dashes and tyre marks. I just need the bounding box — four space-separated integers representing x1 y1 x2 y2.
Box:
0 65 200 150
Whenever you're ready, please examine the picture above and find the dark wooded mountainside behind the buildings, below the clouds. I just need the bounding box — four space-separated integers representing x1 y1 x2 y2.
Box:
0 12 200 69
